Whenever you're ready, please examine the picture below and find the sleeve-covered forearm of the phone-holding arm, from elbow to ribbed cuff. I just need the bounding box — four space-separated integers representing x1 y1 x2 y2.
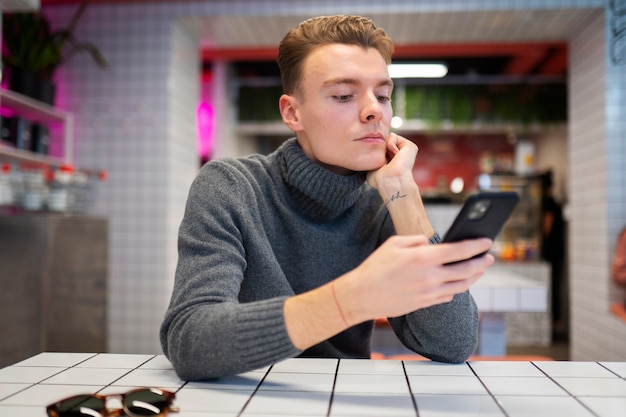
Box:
161 298 300 380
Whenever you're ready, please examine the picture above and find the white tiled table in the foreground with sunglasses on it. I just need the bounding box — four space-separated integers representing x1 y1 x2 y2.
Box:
0 353 626 417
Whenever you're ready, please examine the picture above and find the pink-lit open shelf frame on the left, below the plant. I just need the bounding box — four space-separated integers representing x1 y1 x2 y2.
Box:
0 89 74 166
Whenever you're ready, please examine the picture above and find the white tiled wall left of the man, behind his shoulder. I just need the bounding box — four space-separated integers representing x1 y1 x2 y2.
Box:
46 4 200 352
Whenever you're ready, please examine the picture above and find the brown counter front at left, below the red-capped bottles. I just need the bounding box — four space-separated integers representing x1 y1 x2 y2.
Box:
0 213 109 367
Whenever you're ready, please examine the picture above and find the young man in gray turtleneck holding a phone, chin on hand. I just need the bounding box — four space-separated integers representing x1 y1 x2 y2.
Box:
161 16 494 380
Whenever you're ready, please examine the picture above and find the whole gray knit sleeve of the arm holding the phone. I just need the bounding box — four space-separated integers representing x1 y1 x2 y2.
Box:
160 164 300 380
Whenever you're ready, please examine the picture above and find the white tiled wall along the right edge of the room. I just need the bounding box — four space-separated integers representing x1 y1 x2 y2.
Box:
569 2 626 360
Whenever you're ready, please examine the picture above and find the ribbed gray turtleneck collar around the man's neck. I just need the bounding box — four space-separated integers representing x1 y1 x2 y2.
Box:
277 138 365 220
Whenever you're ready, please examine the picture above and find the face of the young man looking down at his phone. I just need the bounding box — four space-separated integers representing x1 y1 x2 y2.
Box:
282 44 393 174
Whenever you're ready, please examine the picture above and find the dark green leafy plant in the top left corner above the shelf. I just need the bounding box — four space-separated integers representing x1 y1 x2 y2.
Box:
2 0 109 80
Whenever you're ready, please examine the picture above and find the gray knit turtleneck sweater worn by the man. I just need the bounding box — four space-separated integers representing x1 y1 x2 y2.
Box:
160 139 478 380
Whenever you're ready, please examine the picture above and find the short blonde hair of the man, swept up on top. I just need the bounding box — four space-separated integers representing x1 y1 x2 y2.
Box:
278 15 393 94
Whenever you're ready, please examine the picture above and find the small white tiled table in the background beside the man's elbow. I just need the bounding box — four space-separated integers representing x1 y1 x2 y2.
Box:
470 268 549 356
